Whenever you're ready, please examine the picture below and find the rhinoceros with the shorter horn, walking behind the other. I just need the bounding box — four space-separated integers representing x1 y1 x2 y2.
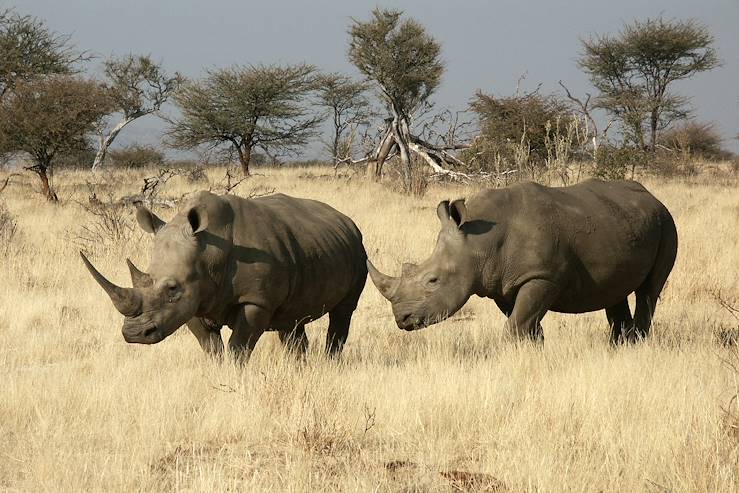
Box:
367 180 677 343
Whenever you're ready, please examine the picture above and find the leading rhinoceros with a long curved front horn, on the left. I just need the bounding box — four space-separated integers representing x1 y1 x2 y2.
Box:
82 192 367 358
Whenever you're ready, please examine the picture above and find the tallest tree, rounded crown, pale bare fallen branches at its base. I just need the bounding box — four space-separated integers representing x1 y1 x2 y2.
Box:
349 8 466 188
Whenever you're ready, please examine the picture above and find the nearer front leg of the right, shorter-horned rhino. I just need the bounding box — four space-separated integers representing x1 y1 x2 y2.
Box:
506 279 559 341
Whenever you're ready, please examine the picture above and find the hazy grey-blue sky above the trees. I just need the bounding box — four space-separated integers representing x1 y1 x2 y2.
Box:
7 0 739 157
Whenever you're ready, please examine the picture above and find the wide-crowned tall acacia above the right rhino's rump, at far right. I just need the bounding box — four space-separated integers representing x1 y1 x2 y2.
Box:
578 17 719 151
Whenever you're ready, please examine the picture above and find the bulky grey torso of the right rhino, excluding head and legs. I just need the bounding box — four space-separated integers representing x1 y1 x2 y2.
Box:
468 180 669 312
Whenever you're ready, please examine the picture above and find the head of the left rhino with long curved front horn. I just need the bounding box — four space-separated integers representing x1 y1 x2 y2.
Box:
80 200 208 344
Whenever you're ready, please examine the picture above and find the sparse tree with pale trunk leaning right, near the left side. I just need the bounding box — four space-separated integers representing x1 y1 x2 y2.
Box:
92 55 183 169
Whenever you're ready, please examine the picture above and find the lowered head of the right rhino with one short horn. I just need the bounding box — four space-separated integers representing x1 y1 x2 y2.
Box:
367 199 480 330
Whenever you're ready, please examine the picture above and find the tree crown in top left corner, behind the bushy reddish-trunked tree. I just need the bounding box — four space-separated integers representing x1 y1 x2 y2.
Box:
0 10 84 99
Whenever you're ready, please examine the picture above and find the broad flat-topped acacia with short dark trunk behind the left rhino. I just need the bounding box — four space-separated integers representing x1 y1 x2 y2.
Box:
168 64 321 176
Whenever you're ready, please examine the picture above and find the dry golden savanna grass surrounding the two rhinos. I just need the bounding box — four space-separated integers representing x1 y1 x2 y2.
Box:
0 164 739 492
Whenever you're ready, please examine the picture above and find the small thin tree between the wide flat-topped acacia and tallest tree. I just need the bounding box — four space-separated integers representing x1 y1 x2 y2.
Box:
317 73 371 164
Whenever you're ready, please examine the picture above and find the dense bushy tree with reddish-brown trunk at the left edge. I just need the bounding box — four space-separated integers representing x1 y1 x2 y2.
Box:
0 76 111 202
